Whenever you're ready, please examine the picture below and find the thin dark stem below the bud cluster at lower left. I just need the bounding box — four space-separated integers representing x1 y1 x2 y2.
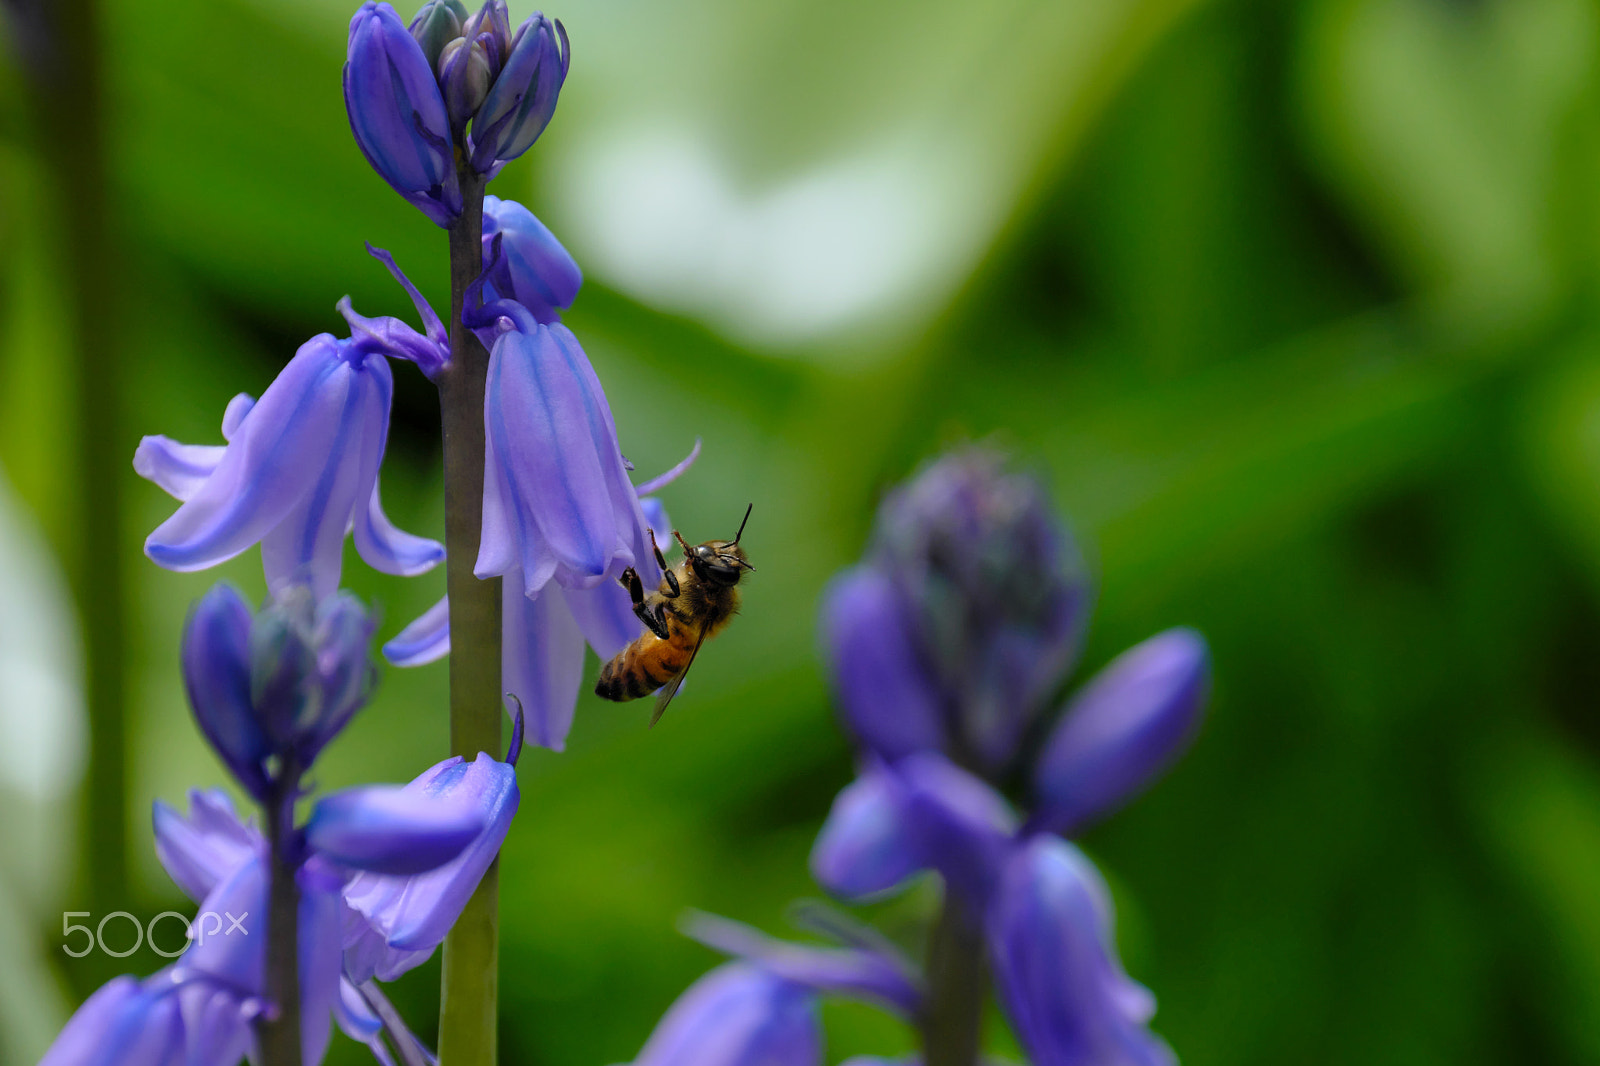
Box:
258 765 301 1066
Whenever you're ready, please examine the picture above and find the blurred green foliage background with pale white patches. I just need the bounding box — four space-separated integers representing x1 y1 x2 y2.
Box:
0 0 1600 1066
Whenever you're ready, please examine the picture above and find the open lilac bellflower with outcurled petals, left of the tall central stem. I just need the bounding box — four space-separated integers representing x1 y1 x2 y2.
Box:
133 305 445 599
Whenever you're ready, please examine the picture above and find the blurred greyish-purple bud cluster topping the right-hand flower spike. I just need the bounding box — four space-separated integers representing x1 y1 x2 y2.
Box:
827 448 1088 773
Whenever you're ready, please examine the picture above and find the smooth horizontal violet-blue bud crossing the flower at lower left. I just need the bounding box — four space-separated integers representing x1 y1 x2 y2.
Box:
306 784 485 876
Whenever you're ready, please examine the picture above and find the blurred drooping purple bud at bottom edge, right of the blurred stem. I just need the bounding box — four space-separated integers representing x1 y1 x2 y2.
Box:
987 836 1178 1066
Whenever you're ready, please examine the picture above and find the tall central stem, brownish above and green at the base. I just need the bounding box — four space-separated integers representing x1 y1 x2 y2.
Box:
437 166 501 1066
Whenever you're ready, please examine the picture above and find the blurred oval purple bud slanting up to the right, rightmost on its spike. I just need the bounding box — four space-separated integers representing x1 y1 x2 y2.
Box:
1034 629 1210 836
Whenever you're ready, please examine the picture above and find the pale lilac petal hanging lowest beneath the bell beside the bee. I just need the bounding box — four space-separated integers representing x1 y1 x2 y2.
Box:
501 582 584 751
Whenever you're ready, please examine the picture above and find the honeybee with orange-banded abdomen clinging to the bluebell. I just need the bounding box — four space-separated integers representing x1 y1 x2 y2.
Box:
595 504 755 725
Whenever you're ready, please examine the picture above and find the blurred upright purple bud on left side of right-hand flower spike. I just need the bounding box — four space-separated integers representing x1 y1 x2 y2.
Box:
822 567 944 759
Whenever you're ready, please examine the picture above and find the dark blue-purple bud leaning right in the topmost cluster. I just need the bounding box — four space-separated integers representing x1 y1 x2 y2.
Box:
472 14 573 174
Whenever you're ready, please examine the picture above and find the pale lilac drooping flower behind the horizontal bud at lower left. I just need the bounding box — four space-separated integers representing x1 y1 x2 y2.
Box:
344 752 520 960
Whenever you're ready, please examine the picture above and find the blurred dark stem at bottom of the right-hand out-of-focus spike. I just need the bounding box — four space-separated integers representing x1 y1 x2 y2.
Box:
920 893 987 1066
